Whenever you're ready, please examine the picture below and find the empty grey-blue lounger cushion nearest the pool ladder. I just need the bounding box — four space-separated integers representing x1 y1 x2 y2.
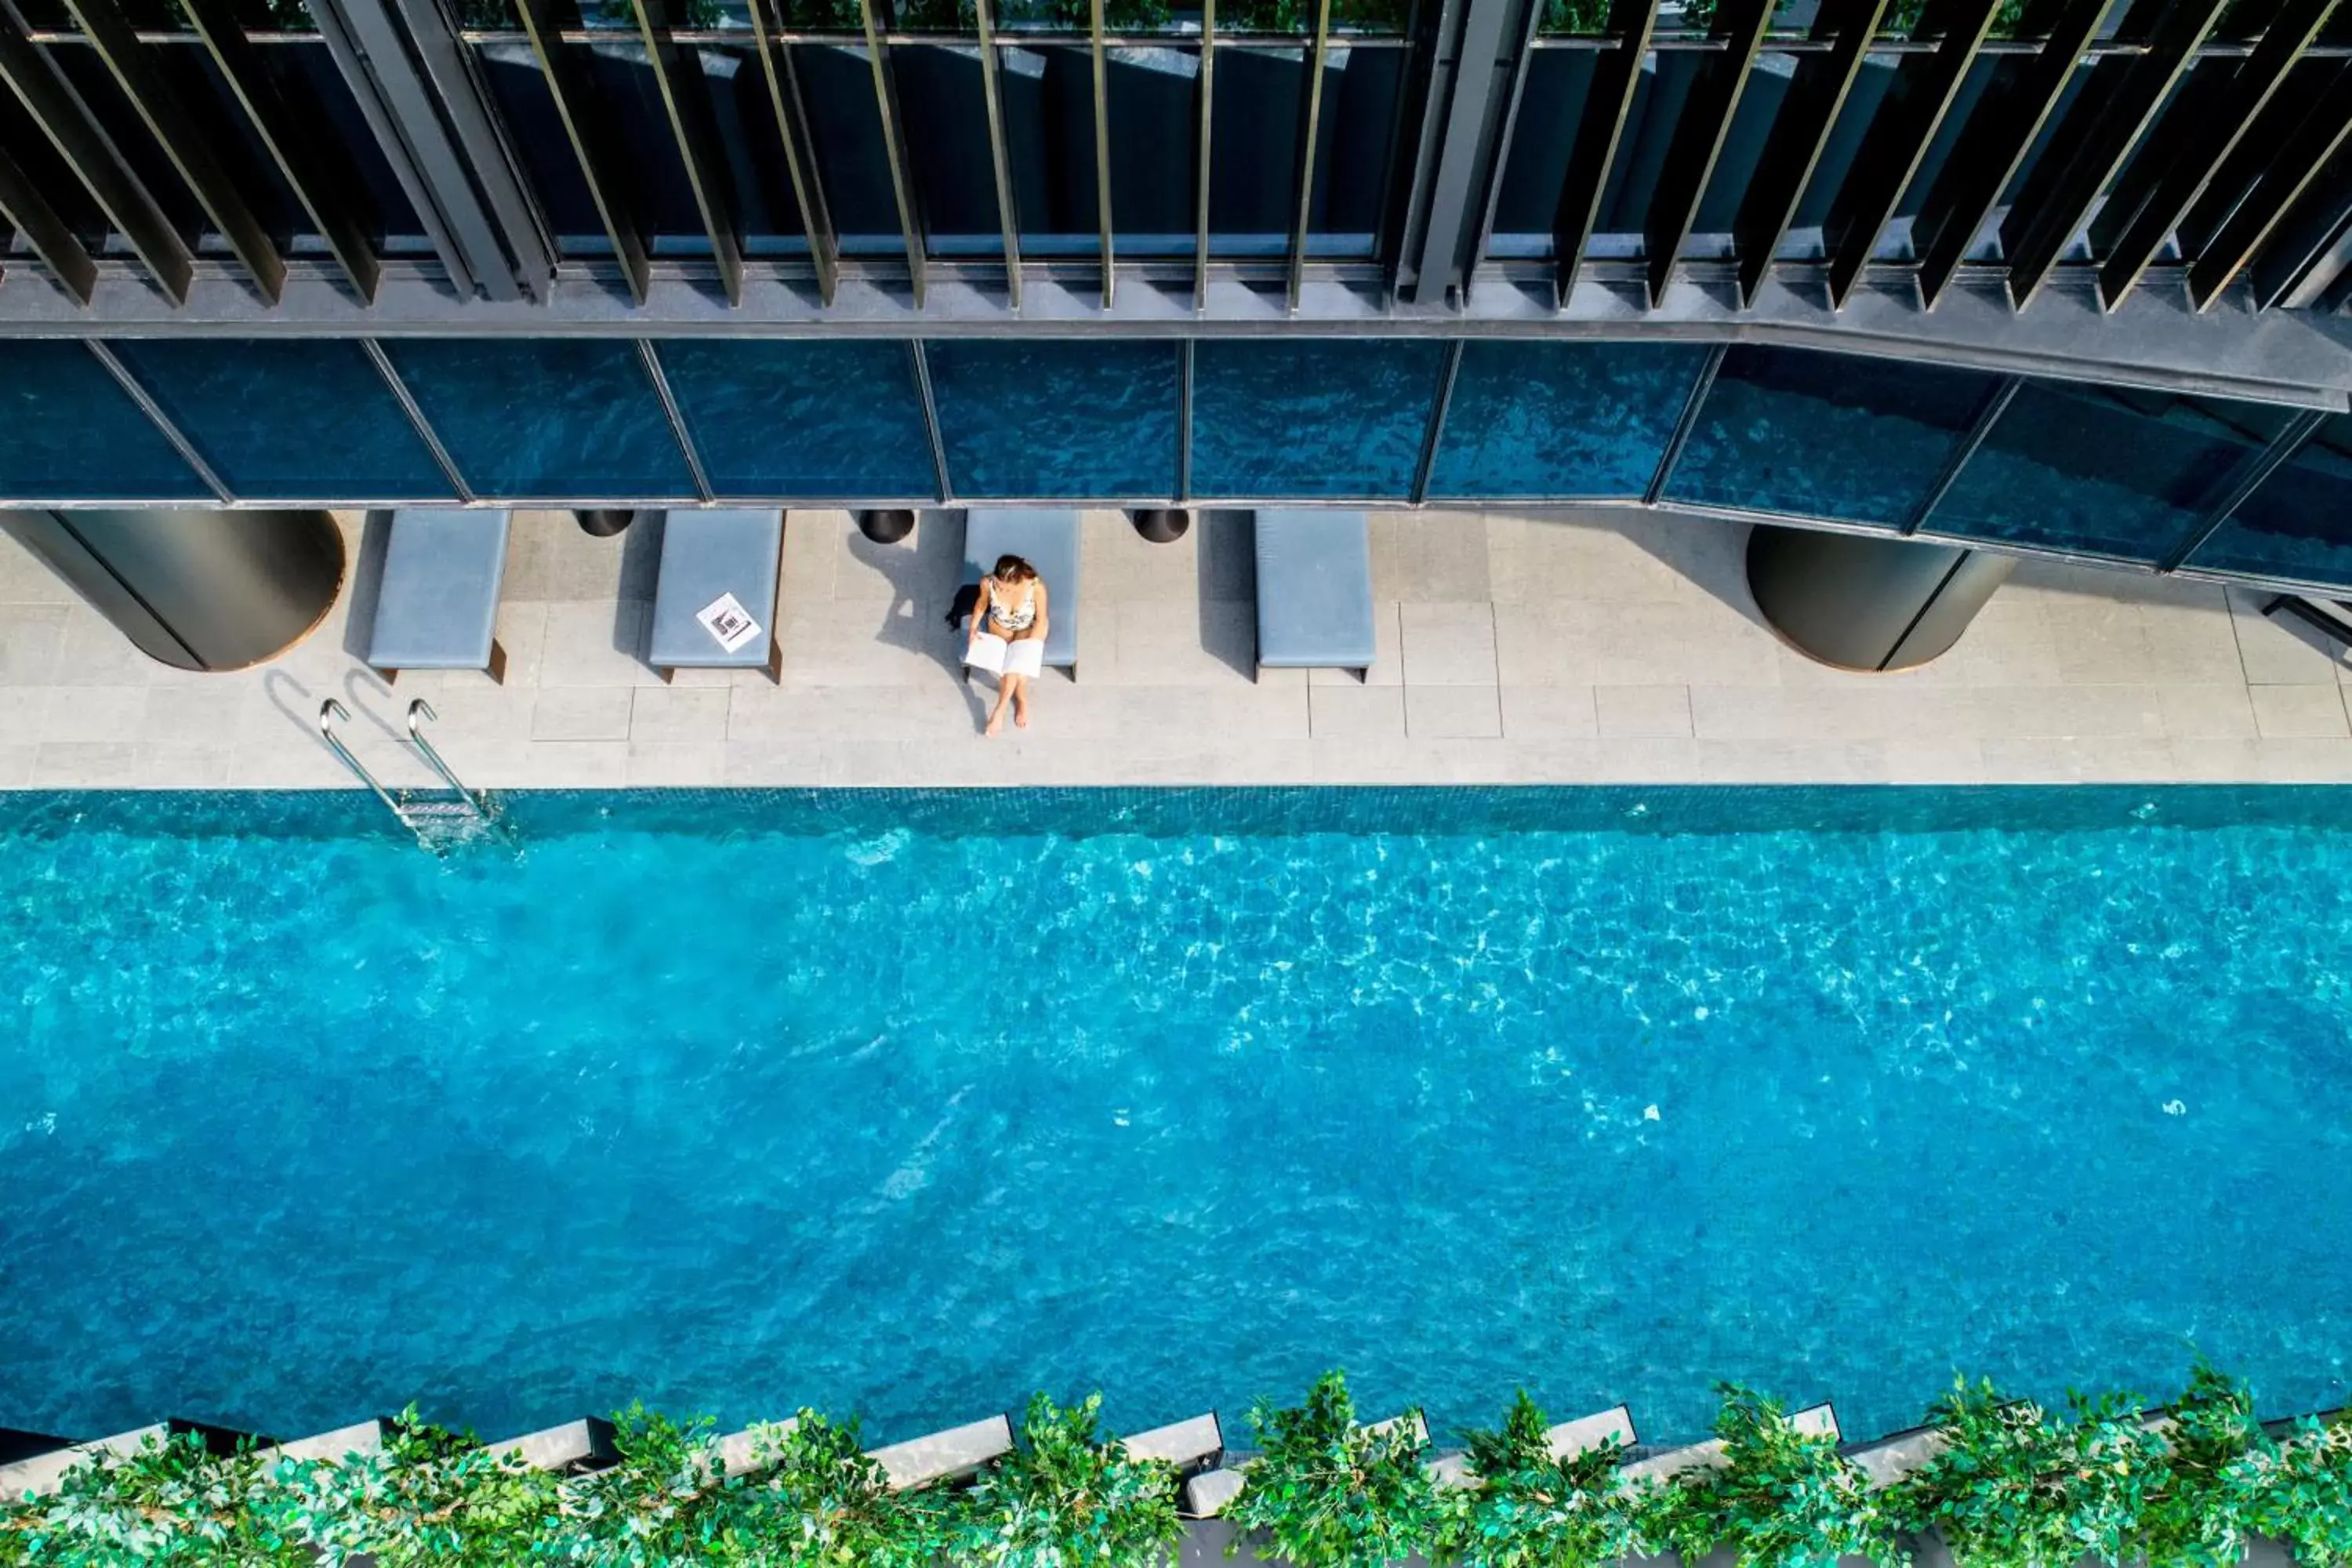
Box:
367 508 510 670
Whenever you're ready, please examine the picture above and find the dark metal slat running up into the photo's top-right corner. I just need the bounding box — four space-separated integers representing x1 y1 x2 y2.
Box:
2091 0 2336 310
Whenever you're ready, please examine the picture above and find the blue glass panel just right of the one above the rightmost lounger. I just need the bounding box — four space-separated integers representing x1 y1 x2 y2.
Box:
1430 341 1708 499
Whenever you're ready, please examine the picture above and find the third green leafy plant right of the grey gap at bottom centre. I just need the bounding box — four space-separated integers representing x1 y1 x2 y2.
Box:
1651 1382 1893 1568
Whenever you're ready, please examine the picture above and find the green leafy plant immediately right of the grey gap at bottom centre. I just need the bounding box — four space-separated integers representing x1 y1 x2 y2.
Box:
1225 1373 1439 1568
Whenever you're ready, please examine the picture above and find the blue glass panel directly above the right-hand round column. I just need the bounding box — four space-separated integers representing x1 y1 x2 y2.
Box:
1665 346 1997 527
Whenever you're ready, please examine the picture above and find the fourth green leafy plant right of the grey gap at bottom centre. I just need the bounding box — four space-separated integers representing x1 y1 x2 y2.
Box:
1893 1380 2166 1568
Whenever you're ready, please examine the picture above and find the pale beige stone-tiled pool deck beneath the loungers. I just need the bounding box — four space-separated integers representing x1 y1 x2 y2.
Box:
0 510 2352 787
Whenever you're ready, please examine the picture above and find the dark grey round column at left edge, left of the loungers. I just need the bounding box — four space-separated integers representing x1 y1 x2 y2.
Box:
5 508 343 670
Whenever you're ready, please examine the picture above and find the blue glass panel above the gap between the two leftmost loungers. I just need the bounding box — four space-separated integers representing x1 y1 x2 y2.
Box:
383 339 694 501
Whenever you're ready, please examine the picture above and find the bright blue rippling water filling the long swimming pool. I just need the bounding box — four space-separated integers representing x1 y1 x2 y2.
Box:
0 789 2352 1439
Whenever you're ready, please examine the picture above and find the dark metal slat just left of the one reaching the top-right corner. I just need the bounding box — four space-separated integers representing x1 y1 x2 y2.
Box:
2002 0 2230 310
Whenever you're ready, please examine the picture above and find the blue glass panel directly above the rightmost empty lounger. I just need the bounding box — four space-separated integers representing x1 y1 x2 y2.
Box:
1192 339 1444 501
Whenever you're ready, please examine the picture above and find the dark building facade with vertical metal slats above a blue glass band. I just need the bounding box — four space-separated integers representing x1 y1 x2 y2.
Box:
0 0 2352 593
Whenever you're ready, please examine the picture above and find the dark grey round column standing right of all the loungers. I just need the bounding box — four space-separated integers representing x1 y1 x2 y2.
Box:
1748 524 2018 670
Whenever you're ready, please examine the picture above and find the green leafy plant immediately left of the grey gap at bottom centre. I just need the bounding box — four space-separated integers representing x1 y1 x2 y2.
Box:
953 1394 1183 1568
